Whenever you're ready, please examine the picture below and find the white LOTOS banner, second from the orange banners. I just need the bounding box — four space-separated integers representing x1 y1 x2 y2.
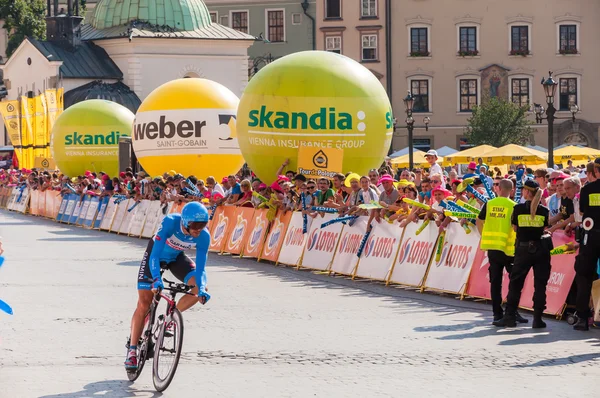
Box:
302 213 344 271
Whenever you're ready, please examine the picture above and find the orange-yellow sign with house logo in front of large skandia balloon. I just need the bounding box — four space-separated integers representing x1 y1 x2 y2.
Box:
298 142 344 180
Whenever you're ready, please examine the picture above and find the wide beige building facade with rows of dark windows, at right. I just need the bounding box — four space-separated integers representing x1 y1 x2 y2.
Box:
390 0 600 149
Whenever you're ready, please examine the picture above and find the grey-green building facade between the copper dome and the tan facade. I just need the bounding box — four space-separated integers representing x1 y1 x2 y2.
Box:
205 0 318 75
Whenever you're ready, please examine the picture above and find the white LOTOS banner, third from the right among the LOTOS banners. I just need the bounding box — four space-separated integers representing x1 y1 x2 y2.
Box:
356 220 403 281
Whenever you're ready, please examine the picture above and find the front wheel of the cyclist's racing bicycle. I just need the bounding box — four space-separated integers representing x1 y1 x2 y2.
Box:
152 309 183 392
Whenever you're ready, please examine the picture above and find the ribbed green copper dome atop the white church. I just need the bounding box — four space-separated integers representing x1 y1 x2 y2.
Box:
90 0 211 31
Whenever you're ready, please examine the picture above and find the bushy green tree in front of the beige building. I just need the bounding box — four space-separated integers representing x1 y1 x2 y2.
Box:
467 98 533 147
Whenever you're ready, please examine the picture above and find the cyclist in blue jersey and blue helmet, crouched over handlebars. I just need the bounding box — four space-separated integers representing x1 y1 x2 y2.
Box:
125 202 210 370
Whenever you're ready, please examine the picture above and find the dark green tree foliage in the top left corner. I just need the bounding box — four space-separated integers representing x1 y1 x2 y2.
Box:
0 0 46 57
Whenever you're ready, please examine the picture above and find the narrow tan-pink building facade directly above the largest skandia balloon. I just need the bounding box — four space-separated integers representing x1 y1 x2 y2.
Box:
317 0 390 87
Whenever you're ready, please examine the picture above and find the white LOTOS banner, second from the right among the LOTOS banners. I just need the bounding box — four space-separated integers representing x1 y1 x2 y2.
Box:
389 221 438 287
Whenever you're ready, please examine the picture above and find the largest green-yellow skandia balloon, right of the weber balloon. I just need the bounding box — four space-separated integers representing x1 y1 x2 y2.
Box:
237 51 393 181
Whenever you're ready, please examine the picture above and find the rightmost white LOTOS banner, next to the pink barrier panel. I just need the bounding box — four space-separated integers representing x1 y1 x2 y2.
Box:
425 223 481 294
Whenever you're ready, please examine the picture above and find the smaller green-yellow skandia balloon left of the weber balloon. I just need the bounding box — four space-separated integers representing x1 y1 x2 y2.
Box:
50 99 135 177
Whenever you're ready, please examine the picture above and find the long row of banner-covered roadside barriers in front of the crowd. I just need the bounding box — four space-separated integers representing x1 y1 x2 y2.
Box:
0 187 576 317
